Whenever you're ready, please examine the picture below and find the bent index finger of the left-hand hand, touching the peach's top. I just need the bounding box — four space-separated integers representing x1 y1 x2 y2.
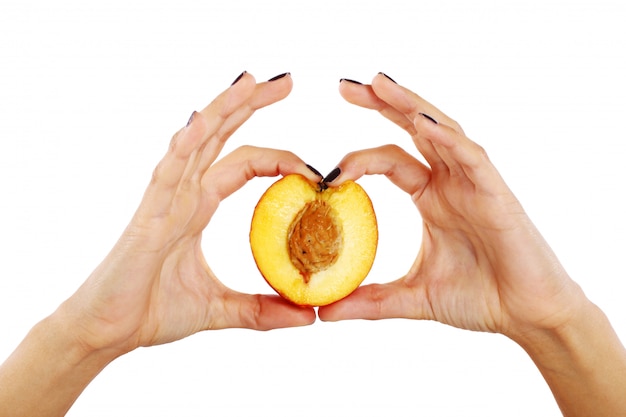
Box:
202 146 321 201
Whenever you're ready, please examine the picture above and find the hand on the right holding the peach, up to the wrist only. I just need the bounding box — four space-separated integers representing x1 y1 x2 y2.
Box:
319 74 586 337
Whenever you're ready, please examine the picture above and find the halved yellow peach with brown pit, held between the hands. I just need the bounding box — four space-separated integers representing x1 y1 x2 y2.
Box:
250 174 378 306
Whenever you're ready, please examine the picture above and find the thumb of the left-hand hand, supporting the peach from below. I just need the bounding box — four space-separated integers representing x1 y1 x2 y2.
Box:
210 290 316 330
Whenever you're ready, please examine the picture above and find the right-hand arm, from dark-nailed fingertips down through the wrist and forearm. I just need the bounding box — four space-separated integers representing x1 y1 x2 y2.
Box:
319 74 626 416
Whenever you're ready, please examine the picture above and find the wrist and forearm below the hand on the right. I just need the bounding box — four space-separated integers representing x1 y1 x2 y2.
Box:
516 298 626 416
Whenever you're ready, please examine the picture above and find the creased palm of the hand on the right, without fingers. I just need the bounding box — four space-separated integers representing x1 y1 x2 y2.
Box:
404 169 507 331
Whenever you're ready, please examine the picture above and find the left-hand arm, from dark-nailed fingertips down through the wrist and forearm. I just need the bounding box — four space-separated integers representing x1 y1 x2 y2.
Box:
0 73 320 416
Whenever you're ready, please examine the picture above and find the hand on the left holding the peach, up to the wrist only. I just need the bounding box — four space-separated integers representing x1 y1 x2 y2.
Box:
57 73 320 354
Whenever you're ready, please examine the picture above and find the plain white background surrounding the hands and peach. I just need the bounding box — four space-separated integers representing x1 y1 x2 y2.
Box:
0 0 626 417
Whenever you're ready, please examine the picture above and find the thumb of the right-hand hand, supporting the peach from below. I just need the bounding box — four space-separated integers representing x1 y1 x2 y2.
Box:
318 280 428 321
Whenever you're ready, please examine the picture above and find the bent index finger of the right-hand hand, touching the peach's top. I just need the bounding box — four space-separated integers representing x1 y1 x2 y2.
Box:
322 145 431 199
